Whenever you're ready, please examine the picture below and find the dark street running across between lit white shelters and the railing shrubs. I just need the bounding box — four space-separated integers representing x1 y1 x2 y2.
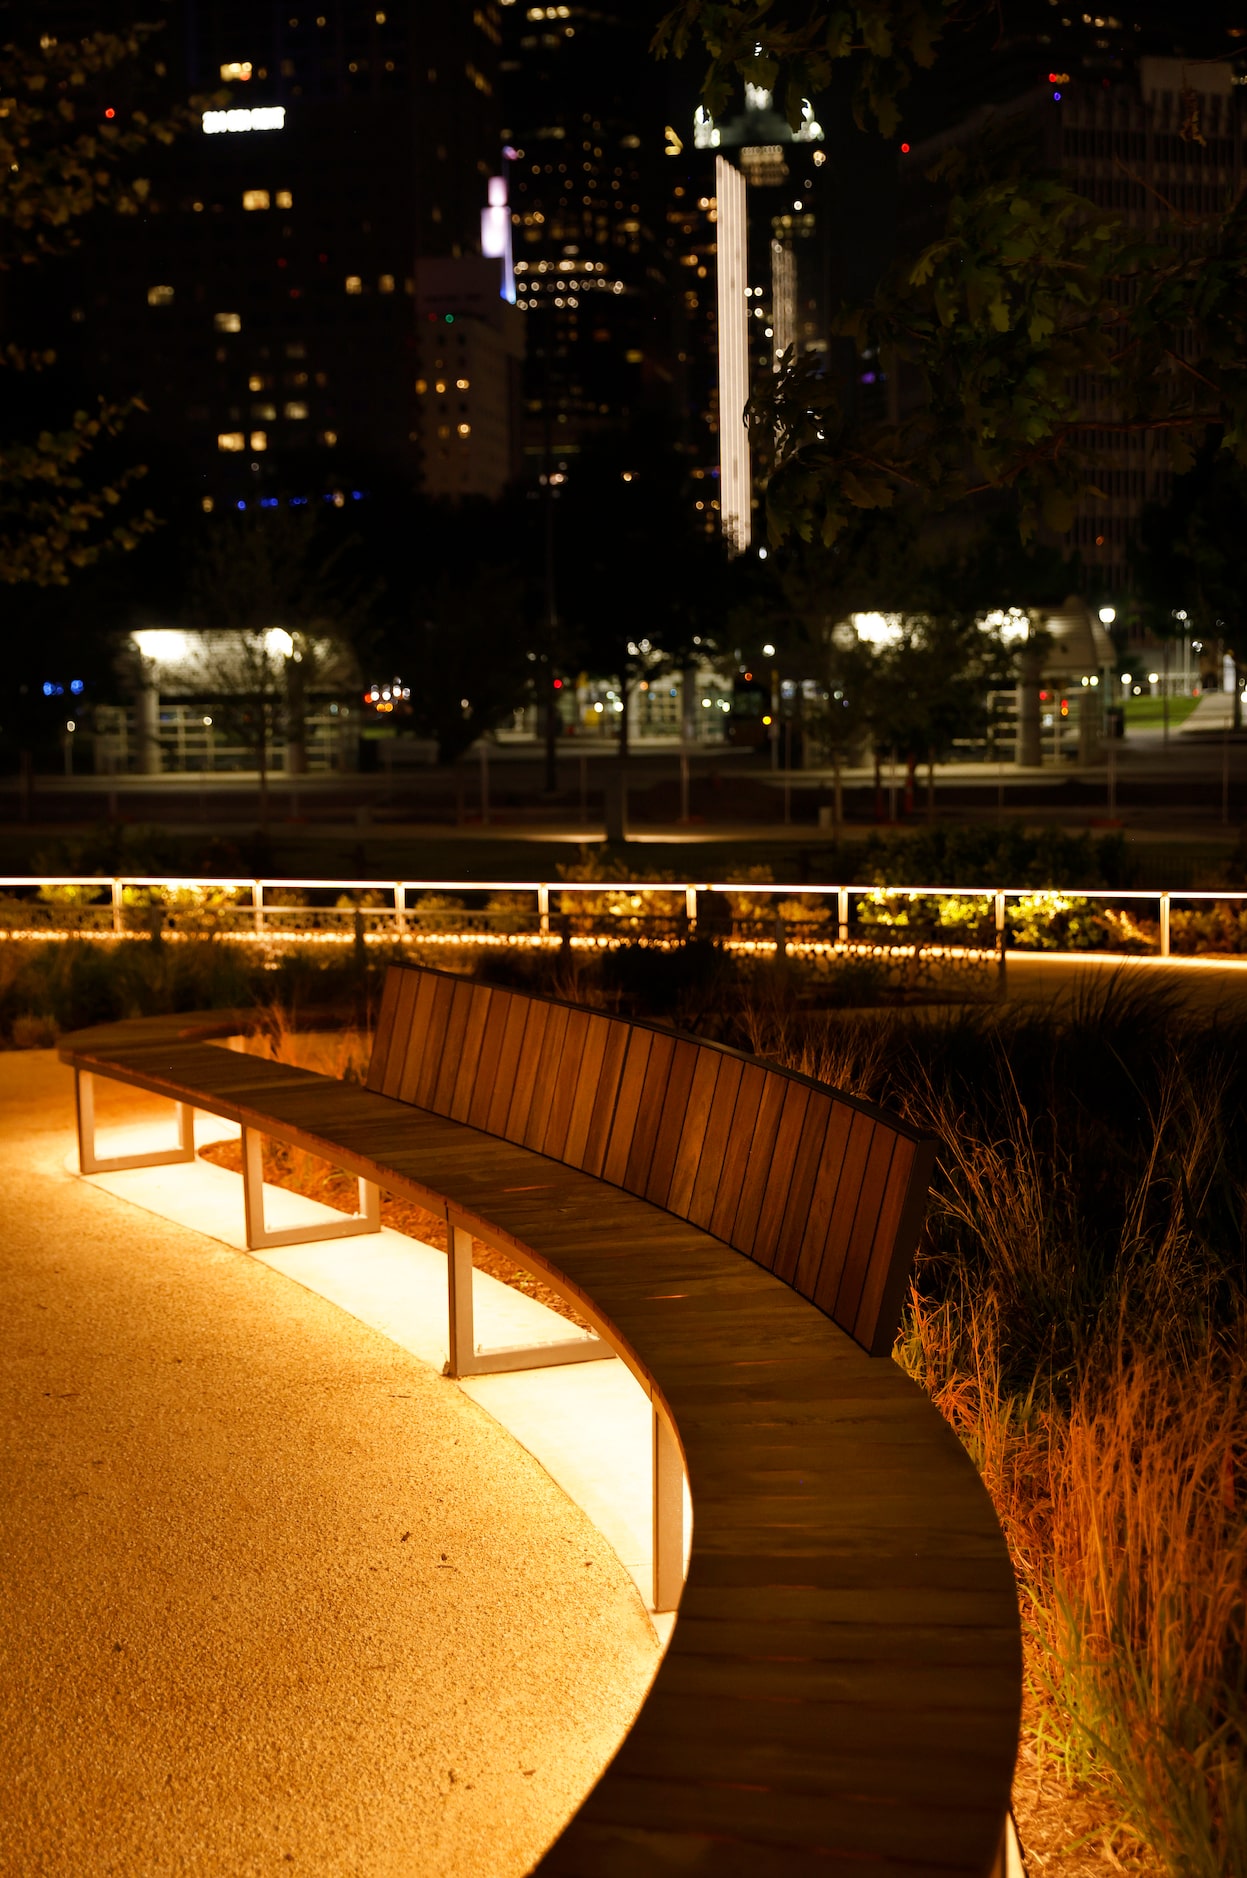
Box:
0 721 1247 839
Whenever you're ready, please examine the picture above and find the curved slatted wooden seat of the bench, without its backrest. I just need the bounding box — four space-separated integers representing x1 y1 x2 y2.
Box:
60 1012 1022 1878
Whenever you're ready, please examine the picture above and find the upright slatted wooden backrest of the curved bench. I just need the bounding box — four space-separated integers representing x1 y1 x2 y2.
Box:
368 965 935 1356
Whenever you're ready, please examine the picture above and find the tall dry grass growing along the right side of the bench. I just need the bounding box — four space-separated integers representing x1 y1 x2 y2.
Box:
742 999 1247 1878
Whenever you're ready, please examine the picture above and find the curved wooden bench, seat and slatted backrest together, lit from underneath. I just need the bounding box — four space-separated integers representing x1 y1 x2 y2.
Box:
60 969 1022 1878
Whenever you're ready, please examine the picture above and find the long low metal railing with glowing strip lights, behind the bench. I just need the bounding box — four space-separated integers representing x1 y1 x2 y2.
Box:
0 873 1247 960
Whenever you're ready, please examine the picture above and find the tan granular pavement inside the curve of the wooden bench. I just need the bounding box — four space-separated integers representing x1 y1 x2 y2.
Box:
0 1052 657 1878
